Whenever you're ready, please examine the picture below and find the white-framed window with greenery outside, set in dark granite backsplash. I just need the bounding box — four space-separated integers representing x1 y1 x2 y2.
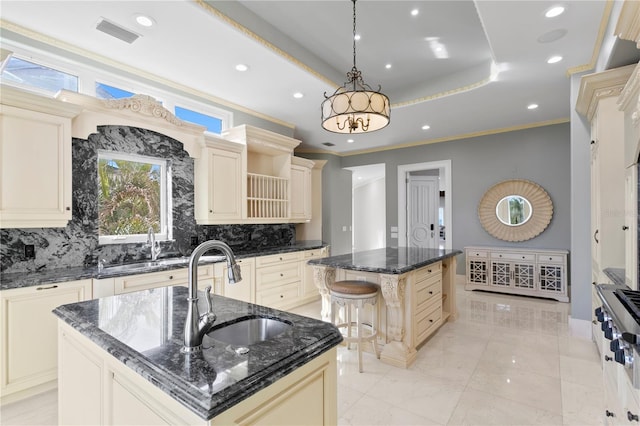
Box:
98 150 171 244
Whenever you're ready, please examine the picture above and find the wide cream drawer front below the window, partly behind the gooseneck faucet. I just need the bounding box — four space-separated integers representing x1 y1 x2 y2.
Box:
114 265 214 294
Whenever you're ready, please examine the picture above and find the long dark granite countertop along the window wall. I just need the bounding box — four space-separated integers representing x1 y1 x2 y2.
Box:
0 240 327 290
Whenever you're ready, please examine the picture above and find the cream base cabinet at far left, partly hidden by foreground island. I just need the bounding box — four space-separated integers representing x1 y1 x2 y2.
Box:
0 280 91 403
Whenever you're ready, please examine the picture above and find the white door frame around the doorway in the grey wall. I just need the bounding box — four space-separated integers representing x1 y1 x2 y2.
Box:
398 160 453 250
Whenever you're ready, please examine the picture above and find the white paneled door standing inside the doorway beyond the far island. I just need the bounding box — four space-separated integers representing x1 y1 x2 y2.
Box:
407 175 440 248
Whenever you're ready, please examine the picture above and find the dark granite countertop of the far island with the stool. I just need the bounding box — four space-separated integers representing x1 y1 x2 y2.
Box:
307 247 462 274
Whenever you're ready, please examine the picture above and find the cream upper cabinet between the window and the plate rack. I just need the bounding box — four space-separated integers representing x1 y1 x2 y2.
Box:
195 137 247 225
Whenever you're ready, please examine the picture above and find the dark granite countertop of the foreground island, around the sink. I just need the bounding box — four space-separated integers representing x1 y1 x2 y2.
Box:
53 286 342 420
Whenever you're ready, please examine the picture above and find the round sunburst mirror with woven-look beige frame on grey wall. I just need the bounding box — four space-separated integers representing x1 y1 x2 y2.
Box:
478 179 553 241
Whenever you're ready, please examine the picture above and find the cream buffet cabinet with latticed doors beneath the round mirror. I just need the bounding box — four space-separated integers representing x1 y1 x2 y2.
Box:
465 247 569 302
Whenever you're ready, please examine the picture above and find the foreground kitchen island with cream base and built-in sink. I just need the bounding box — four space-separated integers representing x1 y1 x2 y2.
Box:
54 286 342 425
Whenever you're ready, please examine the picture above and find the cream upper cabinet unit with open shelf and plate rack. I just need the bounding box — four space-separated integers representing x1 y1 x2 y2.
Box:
196 125 314 224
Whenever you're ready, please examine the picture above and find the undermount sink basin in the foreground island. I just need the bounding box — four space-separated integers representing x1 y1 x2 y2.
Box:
207 317 293 346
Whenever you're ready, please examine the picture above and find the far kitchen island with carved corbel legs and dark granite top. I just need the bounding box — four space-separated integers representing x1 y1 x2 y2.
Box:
308 247 462 368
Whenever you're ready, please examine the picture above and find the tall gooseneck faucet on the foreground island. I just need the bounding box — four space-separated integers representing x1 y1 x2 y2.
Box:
182 240 242 353
